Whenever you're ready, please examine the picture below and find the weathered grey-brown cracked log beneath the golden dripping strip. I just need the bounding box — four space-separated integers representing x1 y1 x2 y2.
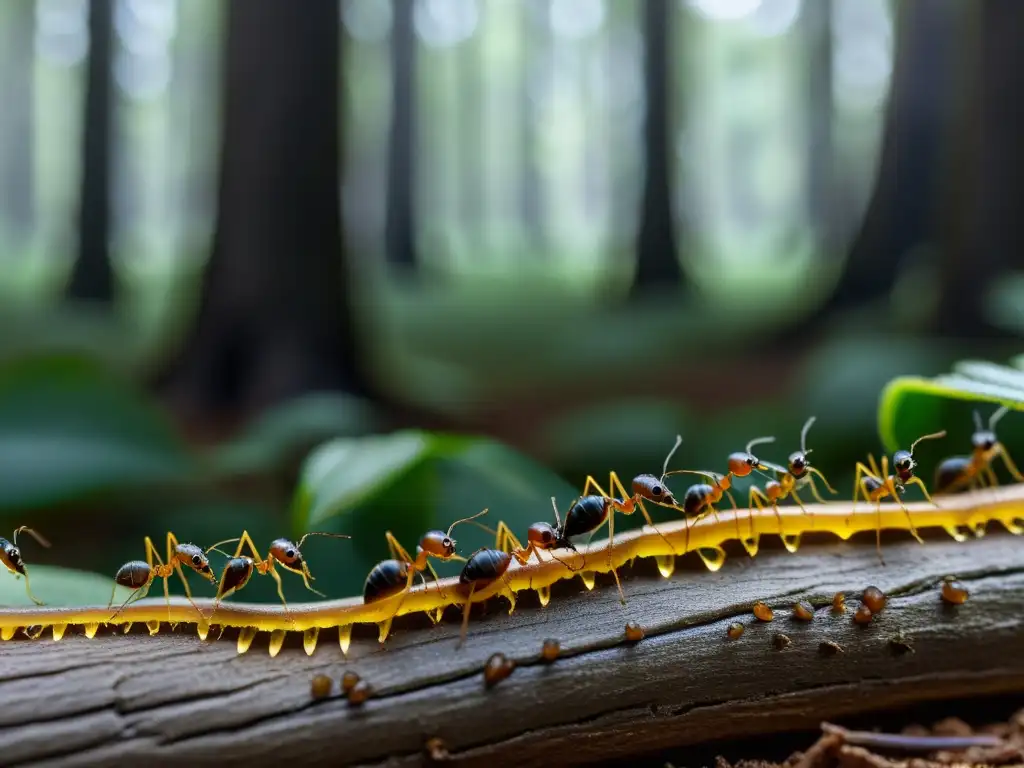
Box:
0 532 1024 768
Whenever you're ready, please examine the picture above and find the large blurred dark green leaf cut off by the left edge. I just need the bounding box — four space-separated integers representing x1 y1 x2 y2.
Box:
0 355 198 518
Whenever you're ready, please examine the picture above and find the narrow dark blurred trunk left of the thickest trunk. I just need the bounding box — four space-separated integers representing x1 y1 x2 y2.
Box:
68 0 114 302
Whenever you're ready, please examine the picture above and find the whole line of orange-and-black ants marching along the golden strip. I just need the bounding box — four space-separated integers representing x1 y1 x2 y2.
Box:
0 407 1024 644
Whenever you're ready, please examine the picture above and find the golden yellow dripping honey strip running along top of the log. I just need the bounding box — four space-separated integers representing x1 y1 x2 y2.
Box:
0 484 1024 655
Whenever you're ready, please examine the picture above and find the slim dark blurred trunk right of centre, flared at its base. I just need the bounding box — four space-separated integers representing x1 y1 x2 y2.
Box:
633 0 683 293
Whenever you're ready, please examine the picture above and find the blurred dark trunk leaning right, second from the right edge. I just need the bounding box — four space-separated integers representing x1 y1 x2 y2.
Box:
815 0 959 319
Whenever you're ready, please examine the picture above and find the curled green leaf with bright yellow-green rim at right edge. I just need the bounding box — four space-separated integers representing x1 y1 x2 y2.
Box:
879 357 1024 452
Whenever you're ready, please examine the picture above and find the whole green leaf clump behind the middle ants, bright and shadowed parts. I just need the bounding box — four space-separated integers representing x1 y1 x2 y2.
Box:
292 431 577 587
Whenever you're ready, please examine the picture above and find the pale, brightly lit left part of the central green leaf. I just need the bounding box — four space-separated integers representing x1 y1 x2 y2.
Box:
296 431 433 525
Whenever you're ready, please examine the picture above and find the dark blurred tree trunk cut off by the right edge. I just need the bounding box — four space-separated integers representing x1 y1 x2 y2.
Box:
932 0 1024 337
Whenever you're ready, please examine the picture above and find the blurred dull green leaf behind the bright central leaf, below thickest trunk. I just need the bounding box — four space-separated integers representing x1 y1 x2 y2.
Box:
212 392 376 474
